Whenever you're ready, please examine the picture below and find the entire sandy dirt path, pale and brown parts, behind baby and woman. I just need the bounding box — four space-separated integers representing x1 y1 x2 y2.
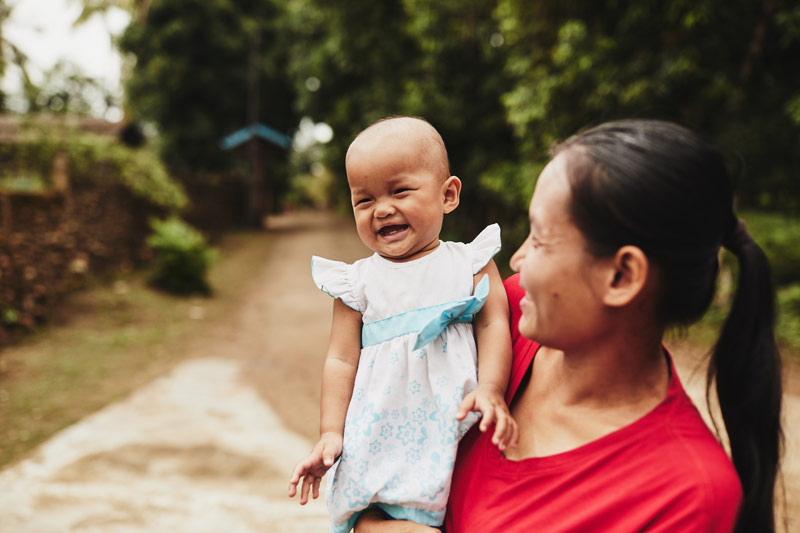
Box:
0 210 800 533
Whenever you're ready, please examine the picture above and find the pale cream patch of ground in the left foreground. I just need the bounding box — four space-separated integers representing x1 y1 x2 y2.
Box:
0 358 328 533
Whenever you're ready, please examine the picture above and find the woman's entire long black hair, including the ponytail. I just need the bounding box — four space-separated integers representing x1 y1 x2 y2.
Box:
554 120 783 532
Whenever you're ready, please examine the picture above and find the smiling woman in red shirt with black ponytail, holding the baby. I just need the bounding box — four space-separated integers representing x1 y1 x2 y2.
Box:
356 121 782 533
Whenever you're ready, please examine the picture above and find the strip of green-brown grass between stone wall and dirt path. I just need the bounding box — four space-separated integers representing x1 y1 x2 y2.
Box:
0 233 270 467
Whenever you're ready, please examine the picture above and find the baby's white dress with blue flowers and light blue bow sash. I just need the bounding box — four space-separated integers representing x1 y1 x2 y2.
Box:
312 224 500 533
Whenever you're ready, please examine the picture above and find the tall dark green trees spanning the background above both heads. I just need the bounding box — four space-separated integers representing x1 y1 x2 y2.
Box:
115 0 800 247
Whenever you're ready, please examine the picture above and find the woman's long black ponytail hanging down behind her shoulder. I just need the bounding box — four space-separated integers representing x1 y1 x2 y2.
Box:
707 218 783 532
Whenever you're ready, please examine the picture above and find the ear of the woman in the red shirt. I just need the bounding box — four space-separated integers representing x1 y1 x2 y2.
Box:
602 246 650 307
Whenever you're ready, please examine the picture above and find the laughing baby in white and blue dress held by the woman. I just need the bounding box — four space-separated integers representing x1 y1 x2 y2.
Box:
289 117 517 533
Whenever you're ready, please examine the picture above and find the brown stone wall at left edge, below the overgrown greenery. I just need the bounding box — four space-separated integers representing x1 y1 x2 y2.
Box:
0 181 159 347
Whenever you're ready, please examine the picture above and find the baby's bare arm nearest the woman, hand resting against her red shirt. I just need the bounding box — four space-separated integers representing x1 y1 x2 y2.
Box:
456 261 519 450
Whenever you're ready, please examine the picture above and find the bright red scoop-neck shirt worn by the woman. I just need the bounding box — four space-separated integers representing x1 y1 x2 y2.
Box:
445 276 742 533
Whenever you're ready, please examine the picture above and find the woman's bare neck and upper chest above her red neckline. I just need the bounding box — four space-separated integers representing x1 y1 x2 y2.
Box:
506 330 669 460
